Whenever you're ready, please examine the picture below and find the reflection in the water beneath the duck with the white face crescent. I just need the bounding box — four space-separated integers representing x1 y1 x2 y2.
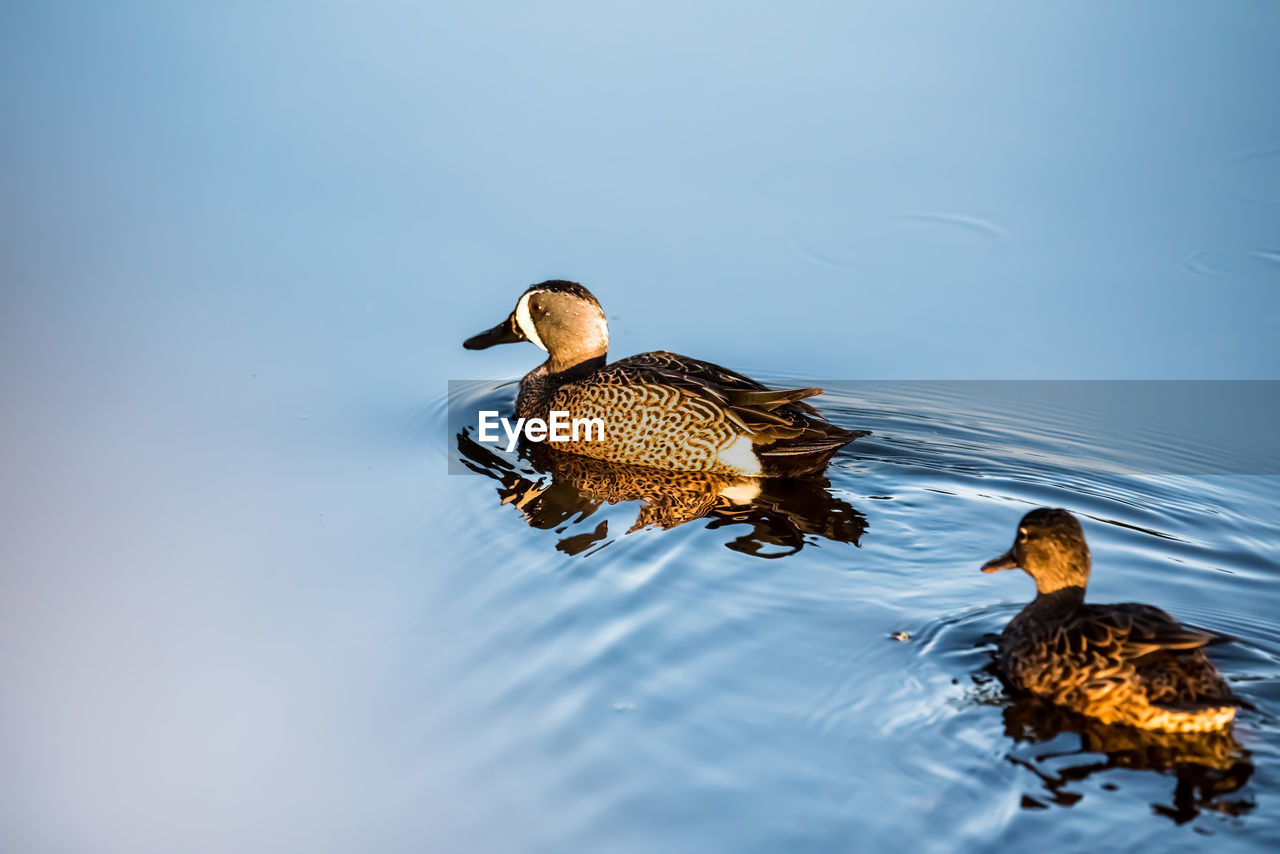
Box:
457 429 867 558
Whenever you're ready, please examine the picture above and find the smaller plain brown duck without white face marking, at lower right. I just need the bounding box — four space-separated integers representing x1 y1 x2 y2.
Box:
982 507 1247 732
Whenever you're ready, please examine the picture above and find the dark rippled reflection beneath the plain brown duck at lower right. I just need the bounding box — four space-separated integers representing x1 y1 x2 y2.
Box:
986 670 1254 825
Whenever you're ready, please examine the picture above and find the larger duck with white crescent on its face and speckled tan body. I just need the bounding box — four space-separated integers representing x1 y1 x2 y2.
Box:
462 279 868 478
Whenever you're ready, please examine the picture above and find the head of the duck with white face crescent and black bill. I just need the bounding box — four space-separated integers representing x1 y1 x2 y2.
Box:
462 279 609 374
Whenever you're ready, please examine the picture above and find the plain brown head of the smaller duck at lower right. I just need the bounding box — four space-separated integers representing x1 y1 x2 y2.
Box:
982 507 1089 593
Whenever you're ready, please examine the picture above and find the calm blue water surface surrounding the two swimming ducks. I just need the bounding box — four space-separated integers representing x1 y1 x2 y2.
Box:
0 0 1280 854
